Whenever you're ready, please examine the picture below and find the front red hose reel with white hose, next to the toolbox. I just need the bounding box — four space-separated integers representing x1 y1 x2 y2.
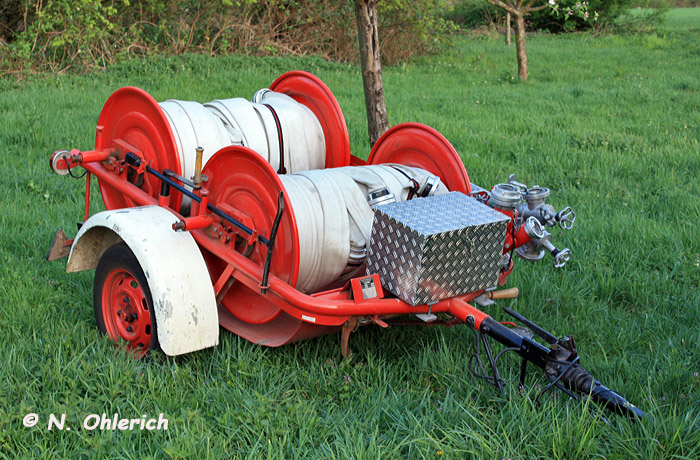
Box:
198 123 470 345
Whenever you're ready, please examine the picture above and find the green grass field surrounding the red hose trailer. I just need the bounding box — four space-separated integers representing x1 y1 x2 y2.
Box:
0 9 700 460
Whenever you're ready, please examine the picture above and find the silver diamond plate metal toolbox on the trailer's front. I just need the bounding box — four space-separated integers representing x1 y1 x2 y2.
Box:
367 192 510 306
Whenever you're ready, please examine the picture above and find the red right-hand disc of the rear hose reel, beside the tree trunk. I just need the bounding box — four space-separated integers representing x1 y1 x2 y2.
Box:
270 70 350 168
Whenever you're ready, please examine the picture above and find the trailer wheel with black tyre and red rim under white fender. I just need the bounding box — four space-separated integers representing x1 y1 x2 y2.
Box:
93 243 159 358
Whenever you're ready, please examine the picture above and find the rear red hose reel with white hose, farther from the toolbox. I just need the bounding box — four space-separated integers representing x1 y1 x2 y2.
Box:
95 71 350 212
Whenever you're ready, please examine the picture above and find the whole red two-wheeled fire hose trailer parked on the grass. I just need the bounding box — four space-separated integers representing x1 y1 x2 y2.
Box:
48 71 643 417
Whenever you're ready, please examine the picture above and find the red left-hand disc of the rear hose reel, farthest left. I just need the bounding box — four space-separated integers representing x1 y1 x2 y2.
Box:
95 86 182 210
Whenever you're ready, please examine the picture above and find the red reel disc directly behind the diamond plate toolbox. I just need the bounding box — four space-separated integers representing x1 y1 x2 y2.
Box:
367 123 472 195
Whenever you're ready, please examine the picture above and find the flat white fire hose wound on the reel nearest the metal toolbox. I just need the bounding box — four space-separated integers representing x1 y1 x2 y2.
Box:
280 165 448 292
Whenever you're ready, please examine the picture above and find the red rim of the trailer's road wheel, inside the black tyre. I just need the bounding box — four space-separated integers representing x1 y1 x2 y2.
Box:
101 268 153 357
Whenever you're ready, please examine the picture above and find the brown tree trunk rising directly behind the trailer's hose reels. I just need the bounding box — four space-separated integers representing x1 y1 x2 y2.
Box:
355 0 389 146
